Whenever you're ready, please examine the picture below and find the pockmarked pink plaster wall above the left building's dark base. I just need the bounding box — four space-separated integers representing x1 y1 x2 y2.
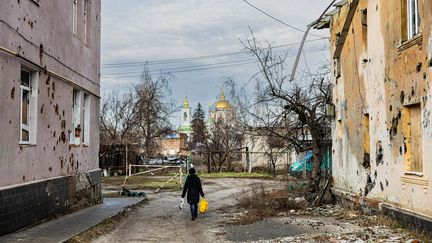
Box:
0 0 101 234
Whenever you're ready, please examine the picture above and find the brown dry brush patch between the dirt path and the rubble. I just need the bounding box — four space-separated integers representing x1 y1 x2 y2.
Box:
232 183 306 225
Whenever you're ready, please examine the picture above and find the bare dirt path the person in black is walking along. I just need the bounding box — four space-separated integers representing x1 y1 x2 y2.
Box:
94 178 277 242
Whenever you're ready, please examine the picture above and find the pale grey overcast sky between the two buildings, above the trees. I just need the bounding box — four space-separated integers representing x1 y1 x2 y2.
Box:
101 0 331 125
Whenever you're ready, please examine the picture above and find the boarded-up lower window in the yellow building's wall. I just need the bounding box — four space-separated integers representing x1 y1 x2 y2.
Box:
404 104 423 172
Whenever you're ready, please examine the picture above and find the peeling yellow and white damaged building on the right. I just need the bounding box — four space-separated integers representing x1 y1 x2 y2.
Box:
315 0 432 227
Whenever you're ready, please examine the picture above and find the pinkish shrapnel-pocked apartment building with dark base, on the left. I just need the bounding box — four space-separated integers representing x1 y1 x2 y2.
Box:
0 0 102 235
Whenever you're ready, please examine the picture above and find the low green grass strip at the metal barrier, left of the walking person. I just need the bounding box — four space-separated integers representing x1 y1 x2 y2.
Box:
102 176 181 190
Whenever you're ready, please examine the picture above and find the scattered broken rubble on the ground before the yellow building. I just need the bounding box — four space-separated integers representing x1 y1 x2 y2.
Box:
224 204 421 243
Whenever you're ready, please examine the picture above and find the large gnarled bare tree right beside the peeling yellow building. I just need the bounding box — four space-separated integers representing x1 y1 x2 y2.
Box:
243 33 331 192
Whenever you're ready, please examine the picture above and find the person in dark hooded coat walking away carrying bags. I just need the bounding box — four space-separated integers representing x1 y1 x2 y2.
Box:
182 168 204 220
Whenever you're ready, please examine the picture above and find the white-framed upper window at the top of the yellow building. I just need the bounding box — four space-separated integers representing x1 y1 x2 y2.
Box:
401 0 420 40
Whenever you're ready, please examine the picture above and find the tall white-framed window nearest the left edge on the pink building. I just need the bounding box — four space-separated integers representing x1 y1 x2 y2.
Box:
20 69 37 144
